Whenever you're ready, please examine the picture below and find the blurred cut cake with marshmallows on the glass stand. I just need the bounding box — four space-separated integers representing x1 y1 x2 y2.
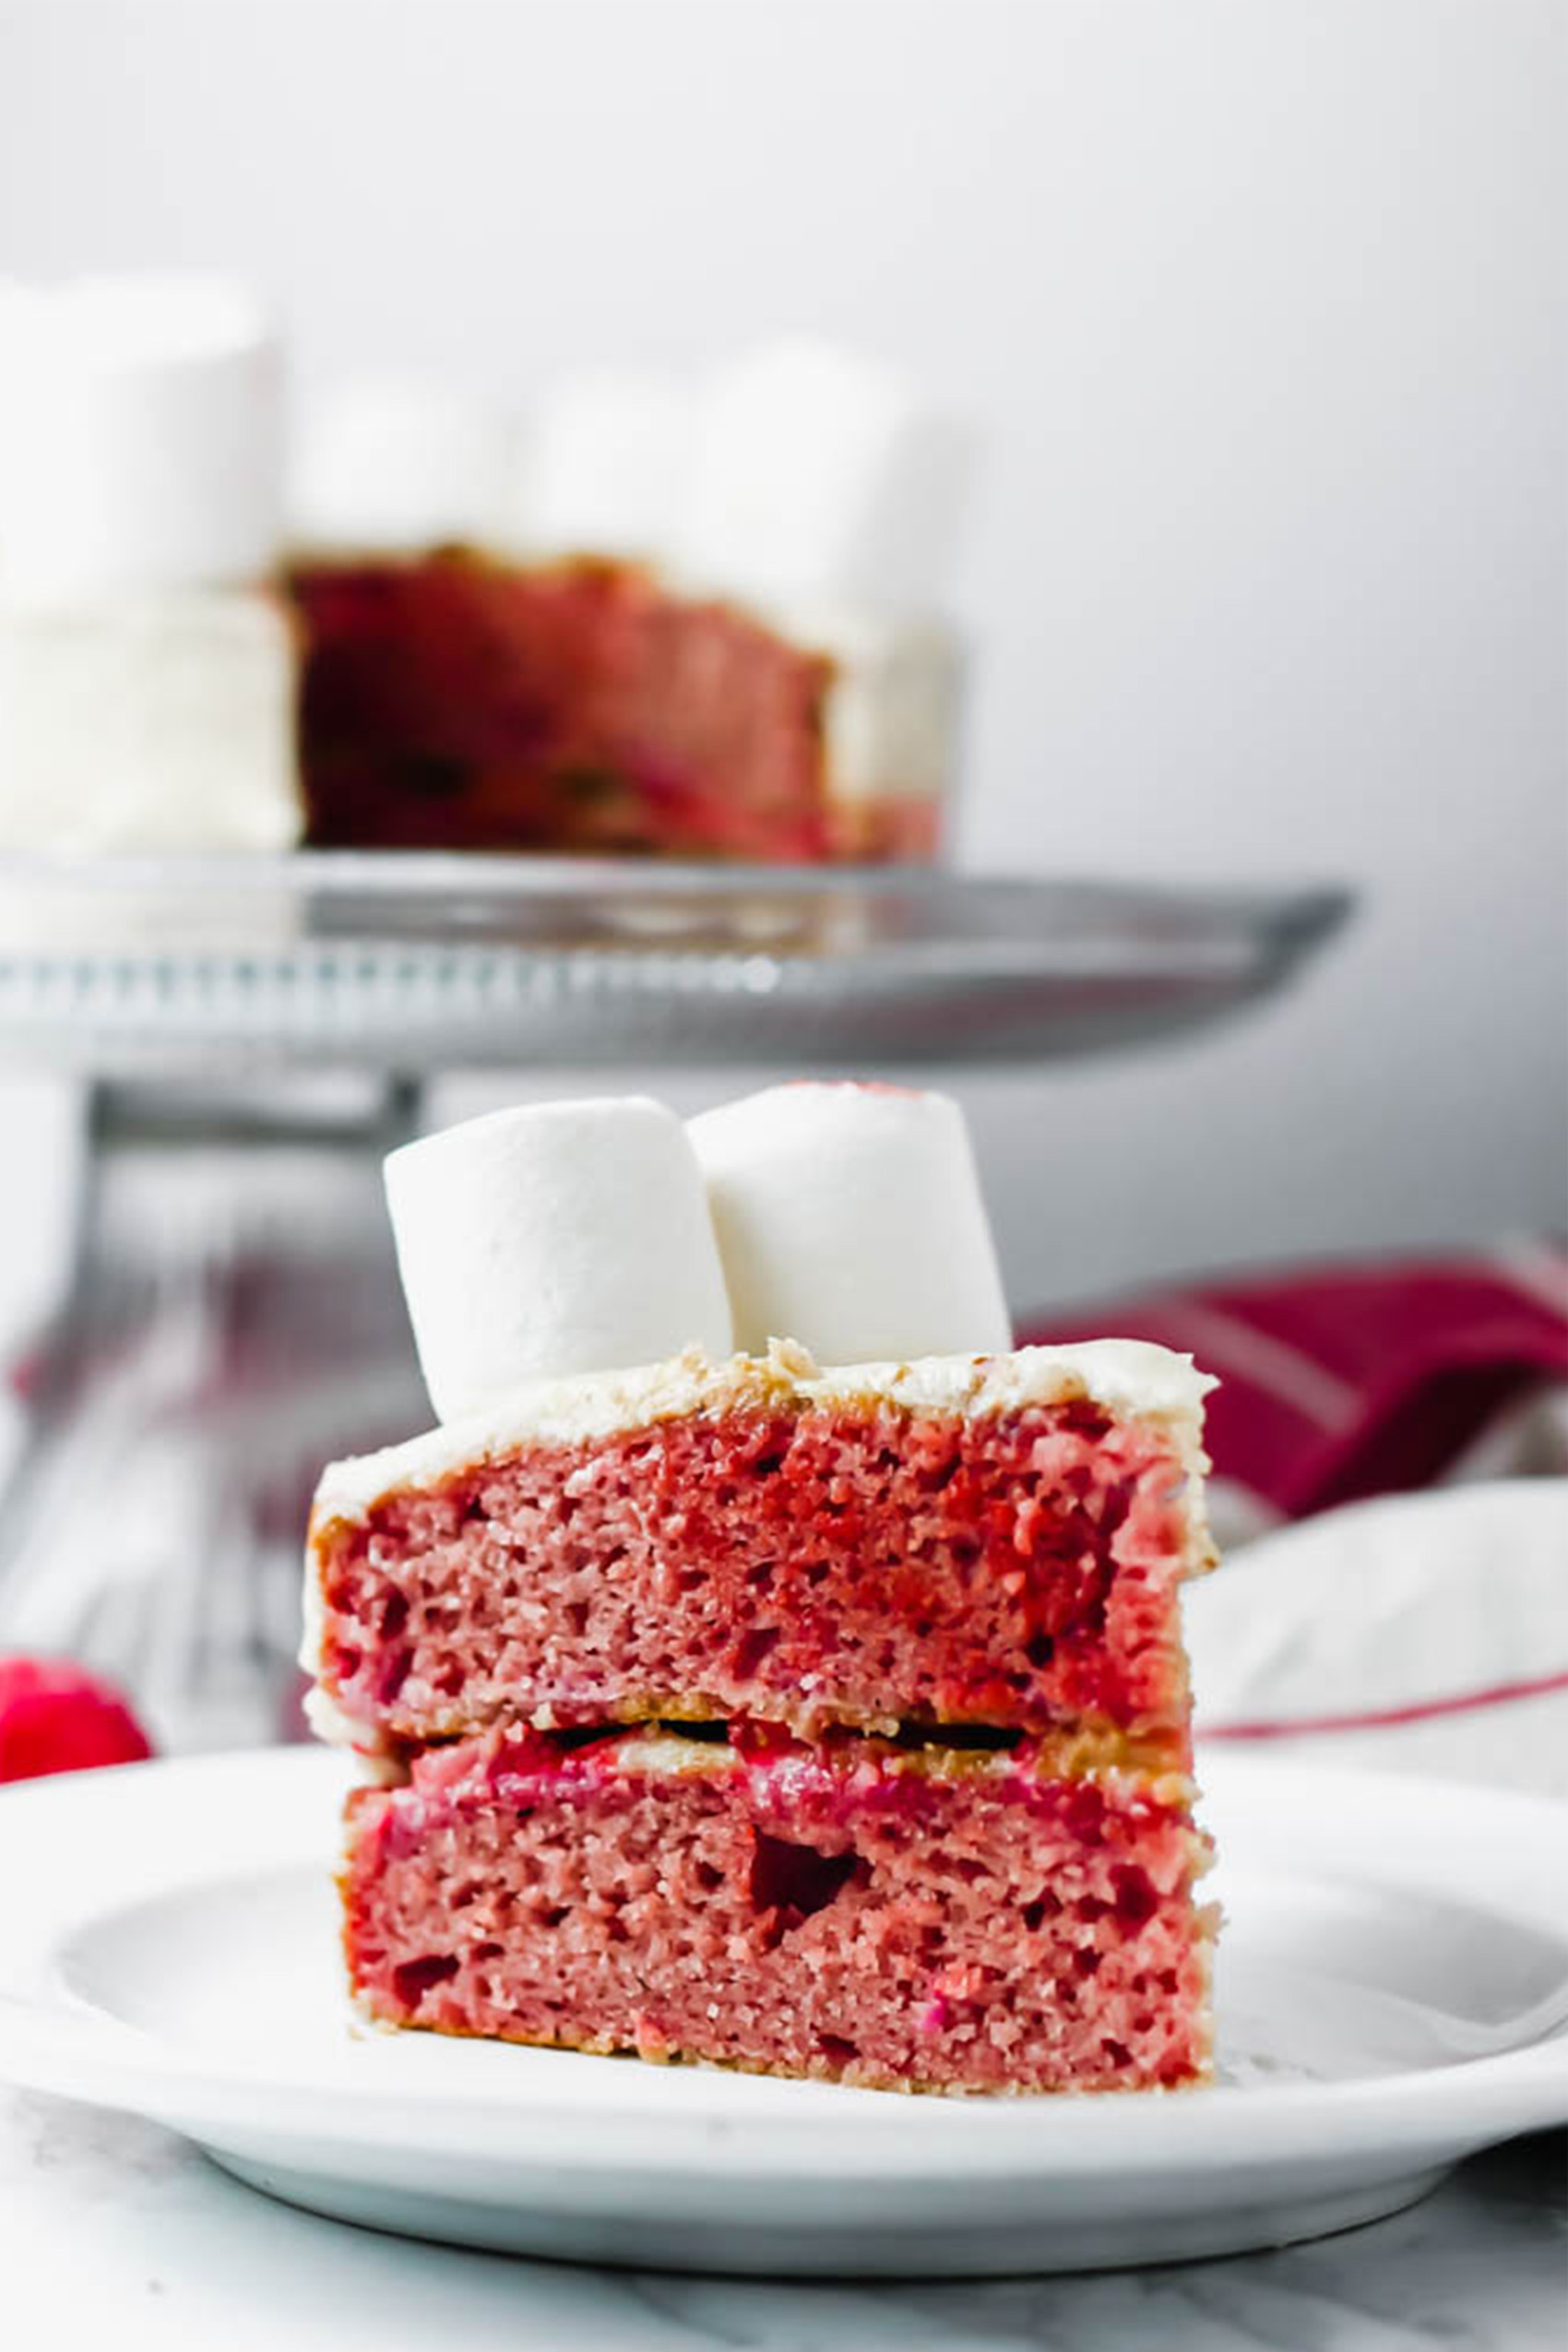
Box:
0 298 967 865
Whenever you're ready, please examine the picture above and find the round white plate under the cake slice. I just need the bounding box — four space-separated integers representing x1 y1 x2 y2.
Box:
0 1750 1568 2275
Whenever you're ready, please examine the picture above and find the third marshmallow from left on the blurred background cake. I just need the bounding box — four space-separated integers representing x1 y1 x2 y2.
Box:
498 369 694 562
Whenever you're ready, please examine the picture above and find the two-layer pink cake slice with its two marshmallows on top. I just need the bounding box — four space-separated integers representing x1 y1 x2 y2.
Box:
305 1087 1211 2091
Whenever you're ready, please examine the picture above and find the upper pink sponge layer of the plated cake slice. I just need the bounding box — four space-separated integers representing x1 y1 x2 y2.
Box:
310 1395 1206 1762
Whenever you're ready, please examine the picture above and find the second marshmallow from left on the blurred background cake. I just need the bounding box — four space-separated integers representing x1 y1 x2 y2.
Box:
289 376 513 552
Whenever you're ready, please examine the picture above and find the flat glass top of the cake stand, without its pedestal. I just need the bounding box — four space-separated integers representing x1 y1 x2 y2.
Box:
0 851 1349 1079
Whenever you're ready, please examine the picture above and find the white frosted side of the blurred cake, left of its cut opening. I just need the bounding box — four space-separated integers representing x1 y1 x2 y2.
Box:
0 588 301 851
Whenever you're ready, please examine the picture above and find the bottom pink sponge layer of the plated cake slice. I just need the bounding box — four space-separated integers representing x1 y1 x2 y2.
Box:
341 1728 1208 2091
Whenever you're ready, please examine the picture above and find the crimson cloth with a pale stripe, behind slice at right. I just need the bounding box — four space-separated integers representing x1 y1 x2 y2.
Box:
1023 1241 1568 1519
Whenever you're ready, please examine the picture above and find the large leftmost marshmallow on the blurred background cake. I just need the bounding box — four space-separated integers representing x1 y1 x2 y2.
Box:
0 275 282 607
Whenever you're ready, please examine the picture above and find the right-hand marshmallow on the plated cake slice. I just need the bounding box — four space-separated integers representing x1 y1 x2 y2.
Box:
689 1085 1014 1364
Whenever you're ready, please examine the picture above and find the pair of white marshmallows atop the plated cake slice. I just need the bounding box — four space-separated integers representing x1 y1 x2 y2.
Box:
386 1085 1011 1420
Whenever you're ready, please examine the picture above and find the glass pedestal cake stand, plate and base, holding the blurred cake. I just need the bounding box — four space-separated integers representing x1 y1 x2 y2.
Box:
0 851 1349 1745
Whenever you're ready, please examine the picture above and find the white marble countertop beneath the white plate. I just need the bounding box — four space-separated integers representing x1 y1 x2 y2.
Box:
0 2091 1568 2352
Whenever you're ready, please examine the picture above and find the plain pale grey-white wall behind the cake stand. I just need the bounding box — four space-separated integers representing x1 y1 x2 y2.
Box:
0 0 1568 1299
